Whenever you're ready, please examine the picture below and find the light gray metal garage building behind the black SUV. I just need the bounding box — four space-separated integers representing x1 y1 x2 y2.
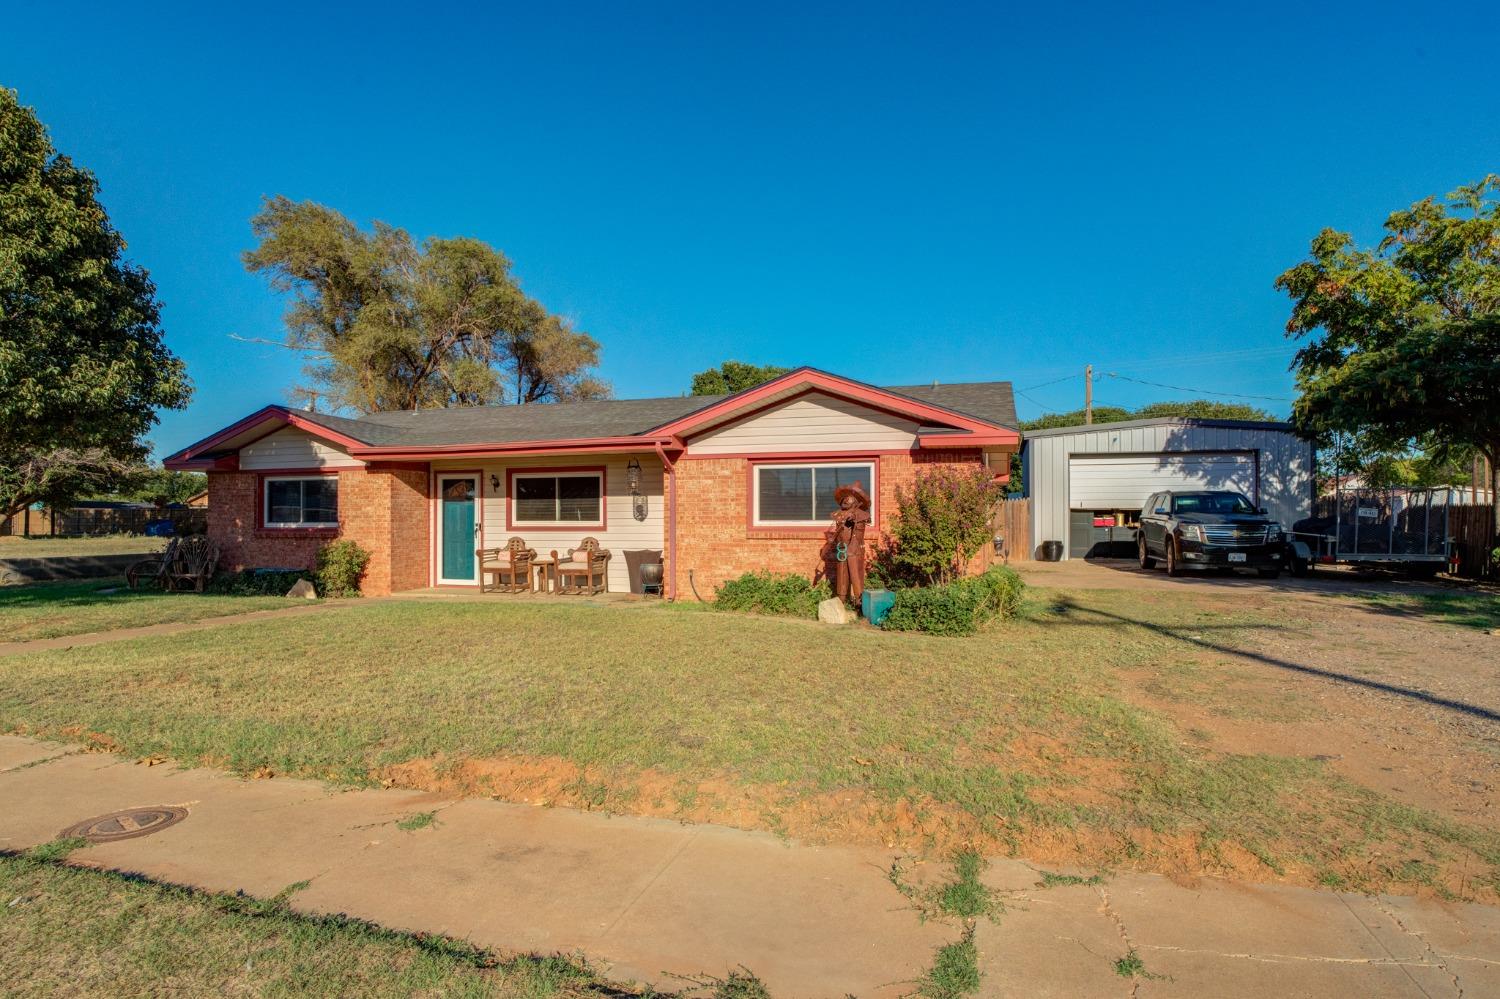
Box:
1022 417 1313 558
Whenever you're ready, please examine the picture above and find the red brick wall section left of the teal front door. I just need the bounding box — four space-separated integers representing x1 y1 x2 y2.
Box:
209 468 429 596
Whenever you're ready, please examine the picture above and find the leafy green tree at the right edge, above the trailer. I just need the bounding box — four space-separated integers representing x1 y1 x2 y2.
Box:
1277 174 1500 534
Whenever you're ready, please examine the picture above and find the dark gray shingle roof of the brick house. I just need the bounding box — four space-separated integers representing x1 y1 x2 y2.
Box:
286 381 1016 447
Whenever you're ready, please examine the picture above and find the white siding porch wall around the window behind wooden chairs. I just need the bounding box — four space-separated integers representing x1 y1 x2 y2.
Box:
432 452 666 593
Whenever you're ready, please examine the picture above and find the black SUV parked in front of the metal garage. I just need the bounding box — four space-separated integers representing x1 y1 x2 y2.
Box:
1136 491 1286 579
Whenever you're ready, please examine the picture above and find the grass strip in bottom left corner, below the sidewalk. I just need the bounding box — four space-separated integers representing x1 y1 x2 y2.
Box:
0 851 630 999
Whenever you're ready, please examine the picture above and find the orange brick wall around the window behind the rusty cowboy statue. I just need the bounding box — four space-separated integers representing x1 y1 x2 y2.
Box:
668 449 992 600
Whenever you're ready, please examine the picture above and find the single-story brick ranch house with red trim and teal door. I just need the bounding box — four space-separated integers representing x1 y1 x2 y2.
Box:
165 368 1020 599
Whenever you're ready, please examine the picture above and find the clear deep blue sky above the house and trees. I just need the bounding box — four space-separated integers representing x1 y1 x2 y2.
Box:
0 2 1500 455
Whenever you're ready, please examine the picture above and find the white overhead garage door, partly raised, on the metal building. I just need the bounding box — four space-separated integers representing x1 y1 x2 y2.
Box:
1068 452 1256 510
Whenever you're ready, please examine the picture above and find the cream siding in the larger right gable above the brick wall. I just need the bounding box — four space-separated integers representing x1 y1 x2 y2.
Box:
687 393 917 455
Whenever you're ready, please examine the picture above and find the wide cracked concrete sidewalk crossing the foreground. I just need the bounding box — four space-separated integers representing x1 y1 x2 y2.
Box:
0 737 1500 999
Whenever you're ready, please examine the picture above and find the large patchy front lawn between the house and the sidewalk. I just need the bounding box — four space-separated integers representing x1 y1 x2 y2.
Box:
0 590 1500 894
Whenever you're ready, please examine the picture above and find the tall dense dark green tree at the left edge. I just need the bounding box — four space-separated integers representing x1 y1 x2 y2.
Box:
0 87 192 519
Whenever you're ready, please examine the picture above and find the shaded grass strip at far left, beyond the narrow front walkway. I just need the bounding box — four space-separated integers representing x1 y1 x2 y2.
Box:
0 579 306 642
